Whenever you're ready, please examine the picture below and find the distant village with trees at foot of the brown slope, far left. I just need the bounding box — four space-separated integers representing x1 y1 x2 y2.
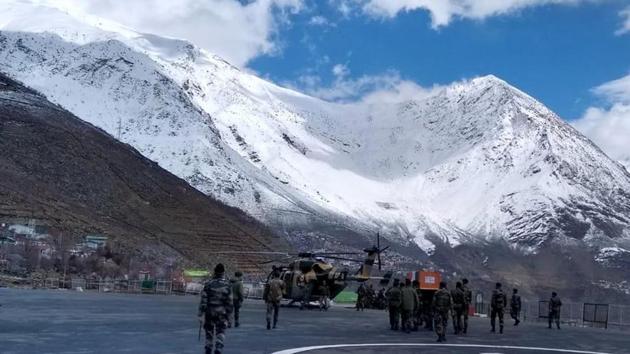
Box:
0 219 264 293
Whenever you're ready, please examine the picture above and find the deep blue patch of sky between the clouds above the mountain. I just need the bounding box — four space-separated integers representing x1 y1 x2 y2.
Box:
248 1 630 120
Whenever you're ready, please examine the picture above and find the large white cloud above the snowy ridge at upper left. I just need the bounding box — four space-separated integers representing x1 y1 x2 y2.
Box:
50 0 304 66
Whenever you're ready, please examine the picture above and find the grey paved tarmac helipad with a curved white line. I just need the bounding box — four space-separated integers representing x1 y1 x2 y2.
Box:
0 289 630 354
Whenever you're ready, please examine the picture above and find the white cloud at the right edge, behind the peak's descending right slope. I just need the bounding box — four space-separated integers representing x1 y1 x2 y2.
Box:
572 75 630 170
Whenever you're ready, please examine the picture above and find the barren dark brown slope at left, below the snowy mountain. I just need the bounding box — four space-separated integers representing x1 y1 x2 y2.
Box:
0 74 285 270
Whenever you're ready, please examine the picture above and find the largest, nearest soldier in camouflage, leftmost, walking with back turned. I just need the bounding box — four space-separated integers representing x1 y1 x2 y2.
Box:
197 263 233 354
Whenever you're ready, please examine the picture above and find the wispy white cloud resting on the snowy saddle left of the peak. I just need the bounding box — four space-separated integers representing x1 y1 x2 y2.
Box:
290 64 439 104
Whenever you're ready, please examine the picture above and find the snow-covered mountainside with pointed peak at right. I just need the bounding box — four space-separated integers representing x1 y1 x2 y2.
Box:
0 0 630 252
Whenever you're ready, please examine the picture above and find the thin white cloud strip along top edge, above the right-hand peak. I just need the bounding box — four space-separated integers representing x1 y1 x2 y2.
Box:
337 0 602 28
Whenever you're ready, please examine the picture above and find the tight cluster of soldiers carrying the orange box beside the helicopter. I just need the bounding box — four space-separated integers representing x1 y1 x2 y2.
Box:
386 279 472 342
